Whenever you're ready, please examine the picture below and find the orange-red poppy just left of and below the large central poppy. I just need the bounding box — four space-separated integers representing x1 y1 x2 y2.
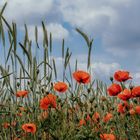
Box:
54 82 68 92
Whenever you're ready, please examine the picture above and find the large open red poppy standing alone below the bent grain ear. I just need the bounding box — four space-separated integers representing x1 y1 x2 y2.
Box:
73 70 91 84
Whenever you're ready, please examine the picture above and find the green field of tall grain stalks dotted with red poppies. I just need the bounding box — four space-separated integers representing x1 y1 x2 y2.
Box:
0 4 140 140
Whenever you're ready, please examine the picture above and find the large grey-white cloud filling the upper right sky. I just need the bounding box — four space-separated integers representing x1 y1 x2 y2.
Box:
60 0 140 57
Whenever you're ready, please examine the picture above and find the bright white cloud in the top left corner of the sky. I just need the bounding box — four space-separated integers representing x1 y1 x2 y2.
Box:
0 0 53 24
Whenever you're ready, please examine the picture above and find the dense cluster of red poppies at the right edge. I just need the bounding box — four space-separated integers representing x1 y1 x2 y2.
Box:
107 71 140 115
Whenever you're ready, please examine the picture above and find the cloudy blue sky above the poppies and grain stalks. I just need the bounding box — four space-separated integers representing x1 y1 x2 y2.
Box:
0 0 140 84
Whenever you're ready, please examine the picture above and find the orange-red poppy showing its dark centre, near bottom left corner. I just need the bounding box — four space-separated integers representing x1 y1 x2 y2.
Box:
22 123 36 134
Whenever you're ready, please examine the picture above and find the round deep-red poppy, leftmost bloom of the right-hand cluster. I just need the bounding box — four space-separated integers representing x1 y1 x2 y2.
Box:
107 83 122 96
